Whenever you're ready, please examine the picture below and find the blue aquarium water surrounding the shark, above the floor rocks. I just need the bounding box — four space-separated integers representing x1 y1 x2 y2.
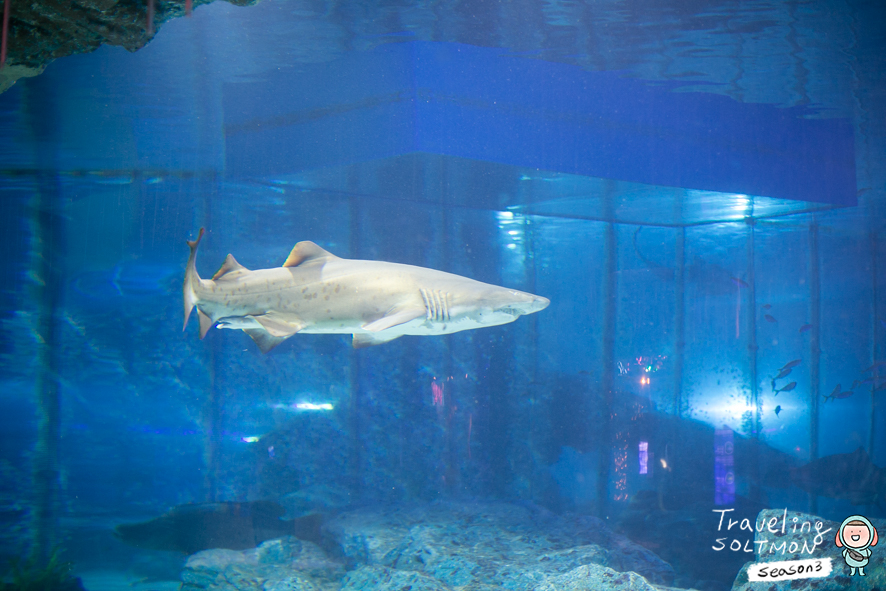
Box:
0 0 886 589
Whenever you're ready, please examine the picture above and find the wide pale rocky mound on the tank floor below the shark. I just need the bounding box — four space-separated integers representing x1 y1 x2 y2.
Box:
182 503 692 591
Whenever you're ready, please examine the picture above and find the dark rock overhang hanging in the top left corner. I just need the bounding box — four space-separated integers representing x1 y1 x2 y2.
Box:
0 0 258 92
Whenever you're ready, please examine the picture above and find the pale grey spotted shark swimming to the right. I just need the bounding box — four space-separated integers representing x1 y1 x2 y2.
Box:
184 228 550 353
